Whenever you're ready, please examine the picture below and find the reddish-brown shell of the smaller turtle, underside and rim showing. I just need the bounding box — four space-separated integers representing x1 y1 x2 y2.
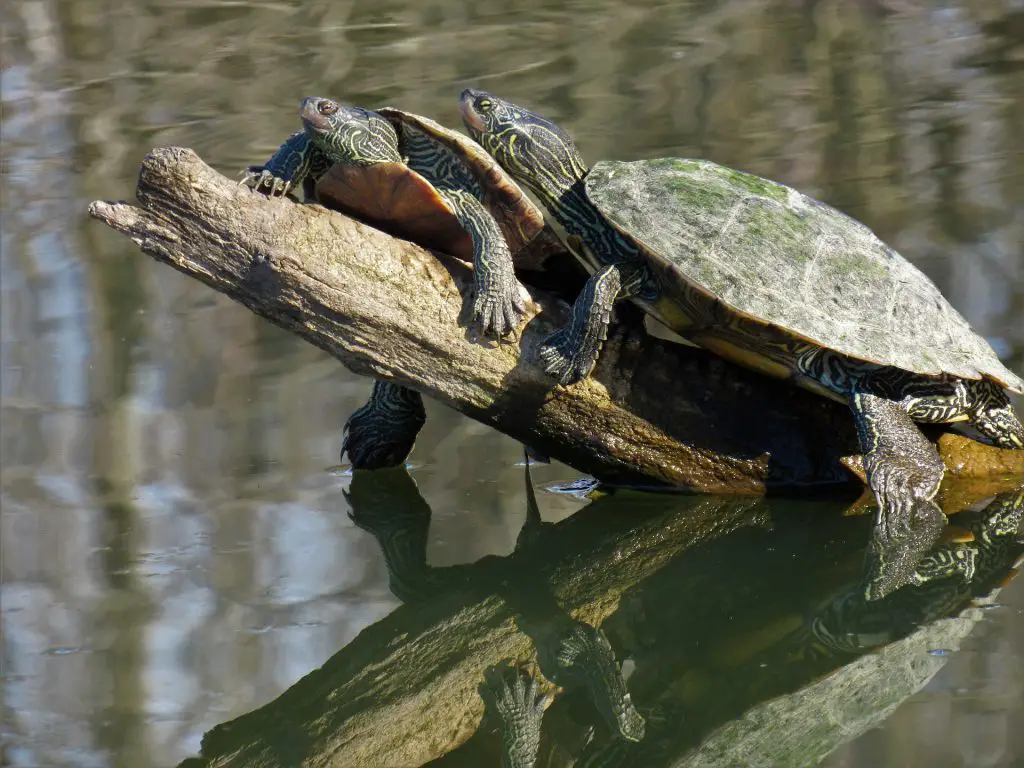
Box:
316 108 562 261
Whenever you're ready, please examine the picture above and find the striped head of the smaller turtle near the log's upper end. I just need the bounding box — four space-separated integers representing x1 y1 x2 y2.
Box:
299 96 401 165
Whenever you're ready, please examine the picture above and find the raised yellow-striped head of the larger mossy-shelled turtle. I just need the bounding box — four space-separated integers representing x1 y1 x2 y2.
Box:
459 88 587 200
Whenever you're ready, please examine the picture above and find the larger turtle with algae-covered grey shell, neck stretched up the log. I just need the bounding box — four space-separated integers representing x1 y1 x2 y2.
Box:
460 88 1024 536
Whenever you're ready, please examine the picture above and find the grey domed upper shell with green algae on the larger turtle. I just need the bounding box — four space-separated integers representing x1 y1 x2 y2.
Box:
586 158 1024 392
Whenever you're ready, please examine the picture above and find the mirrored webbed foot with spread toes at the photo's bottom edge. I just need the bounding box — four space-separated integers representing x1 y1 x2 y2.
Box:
480 666 551 768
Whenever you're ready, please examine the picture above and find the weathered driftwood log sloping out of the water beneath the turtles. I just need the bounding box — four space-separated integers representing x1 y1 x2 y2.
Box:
89 147 1024 494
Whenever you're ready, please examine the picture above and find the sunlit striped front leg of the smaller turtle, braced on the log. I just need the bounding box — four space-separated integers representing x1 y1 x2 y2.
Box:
439 189 526 337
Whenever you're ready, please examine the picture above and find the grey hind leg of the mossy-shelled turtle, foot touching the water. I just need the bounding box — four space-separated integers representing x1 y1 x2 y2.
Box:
850 390 945 540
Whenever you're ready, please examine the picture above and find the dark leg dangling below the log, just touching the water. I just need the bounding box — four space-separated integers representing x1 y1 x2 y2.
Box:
341 381 427 469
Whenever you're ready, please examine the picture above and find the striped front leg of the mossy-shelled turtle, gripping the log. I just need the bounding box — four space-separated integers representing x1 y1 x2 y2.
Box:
538 264 643 386
